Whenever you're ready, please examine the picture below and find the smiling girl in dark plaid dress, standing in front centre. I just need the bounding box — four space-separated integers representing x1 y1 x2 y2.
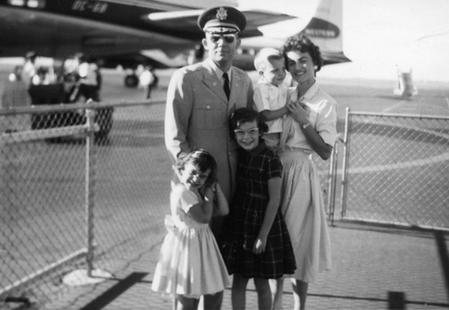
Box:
223 108 295 310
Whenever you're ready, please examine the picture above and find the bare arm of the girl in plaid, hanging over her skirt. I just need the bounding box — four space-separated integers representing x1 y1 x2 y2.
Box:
253 177 281 254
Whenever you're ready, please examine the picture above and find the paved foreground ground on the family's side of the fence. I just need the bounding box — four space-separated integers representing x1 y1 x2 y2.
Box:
40 223 449 310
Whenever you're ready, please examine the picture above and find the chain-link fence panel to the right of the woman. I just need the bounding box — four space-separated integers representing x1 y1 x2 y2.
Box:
341 110 449 230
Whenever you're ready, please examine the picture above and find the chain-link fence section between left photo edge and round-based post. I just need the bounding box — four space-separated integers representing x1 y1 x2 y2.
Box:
0 104 91 308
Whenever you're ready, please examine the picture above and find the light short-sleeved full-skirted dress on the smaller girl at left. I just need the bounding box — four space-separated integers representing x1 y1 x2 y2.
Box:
152 184 229 298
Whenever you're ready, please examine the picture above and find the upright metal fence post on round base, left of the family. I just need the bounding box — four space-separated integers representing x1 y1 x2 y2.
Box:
85 109 95 277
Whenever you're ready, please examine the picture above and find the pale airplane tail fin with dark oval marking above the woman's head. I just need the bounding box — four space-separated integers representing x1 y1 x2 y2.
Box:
301 0 351 65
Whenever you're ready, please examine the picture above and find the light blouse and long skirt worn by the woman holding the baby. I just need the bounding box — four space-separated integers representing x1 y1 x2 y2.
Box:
279 83 337 282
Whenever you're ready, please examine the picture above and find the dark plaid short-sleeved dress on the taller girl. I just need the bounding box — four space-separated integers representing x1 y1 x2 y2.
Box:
223 143 295 279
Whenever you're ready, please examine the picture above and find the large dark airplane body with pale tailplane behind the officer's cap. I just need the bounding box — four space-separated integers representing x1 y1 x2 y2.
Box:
0 0 293 57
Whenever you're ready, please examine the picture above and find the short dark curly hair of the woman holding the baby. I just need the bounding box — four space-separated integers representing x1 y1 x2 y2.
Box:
282 34 323 72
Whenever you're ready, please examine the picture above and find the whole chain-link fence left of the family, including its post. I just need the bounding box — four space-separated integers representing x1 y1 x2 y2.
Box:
0 102 171 309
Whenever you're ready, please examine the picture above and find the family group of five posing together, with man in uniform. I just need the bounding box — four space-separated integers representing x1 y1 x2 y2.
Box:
152 6 337 310
